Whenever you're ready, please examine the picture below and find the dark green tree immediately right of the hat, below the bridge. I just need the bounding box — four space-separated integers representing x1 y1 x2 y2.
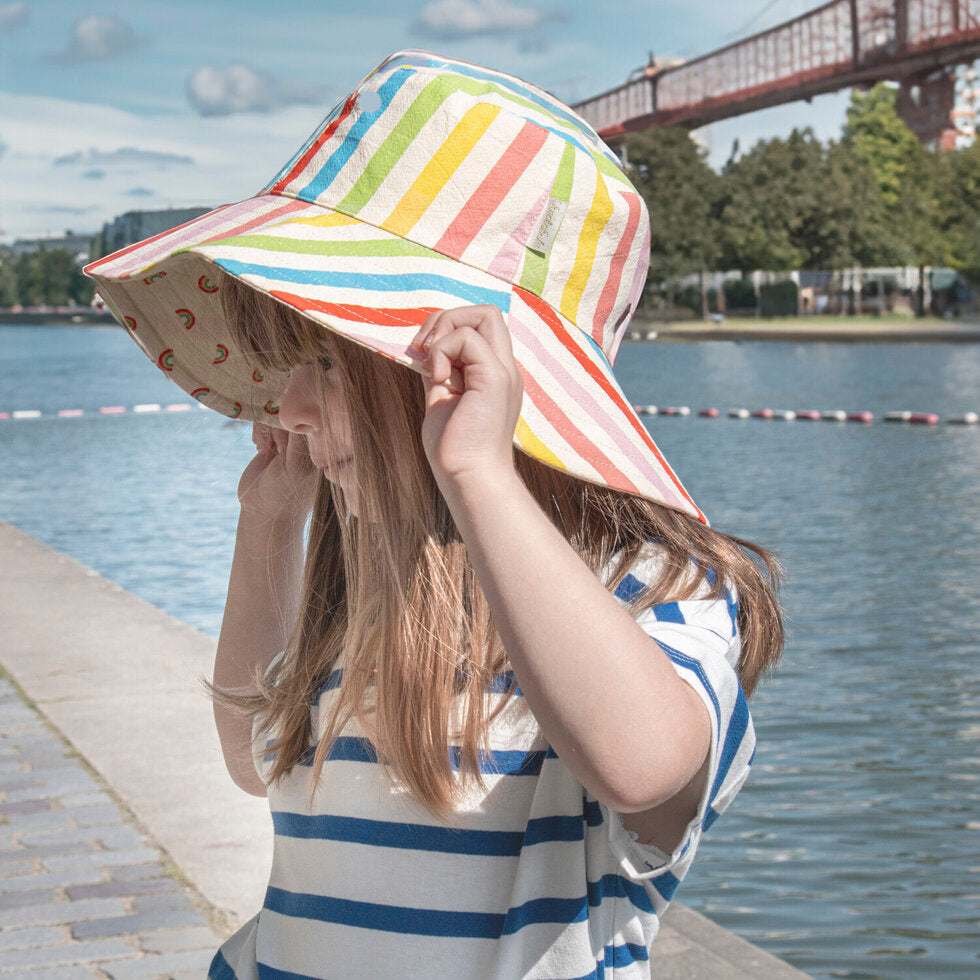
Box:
626 127 720 310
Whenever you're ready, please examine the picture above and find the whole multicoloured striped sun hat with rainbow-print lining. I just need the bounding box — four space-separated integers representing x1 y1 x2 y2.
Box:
85 51 707 523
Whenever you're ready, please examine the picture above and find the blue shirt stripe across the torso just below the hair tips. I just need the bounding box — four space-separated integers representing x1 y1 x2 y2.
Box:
272 810 585 857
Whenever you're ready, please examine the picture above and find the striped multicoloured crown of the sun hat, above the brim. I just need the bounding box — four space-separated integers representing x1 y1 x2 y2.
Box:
266 51 649 362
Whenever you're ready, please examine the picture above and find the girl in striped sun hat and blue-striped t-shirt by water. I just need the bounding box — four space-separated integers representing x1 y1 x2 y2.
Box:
87 52 782 980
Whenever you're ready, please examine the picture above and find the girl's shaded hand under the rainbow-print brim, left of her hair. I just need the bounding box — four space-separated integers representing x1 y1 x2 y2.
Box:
238 422 317 524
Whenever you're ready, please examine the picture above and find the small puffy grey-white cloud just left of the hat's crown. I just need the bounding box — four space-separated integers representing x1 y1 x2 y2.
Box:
187 64 325 116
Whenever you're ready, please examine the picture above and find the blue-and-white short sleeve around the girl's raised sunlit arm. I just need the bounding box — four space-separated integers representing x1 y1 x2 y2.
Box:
604 558 755 900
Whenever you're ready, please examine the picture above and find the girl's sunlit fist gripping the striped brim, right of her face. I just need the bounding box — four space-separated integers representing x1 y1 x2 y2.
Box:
412 306 524 492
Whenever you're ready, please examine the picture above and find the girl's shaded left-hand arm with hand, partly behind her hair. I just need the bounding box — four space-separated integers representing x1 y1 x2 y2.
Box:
214 425 316 796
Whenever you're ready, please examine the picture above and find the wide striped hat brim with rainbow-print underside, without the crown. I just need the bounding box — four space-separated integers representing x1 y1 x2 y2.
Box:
85 194 705 522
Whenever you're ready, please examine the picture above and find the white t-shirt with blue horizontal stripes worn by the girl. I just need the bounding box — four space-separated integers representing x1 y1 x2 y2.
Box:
209 545 755 980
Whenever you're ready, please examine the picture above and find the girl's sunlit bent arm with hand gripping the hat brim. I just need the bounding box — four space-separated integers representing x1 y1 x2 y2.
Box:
415 307 711 849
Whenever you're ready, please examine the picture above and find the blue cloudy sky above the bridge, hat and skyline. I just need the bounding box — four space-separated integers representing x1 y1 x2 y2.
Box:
0 0 848 244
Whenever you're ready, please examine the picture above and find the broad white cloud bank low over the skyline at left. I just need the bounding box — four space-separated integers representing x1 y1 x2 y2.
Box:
0 91 322 241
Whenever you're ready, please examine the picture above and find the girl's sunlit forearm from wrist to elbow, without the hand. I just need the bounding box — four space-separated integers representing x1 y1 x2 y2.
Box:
444 473 710 812
